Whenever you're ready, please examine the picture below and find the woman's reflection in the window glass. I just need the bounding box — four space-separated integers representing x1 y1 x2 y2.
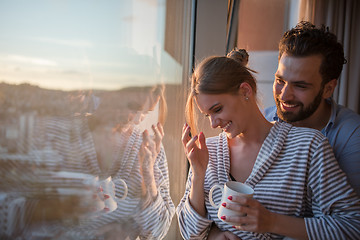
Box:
0 87 175 239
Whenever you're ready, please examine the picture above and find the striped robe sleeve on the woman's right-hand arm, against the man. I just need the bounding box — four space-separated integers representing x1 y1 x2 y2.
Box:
305 139 360 239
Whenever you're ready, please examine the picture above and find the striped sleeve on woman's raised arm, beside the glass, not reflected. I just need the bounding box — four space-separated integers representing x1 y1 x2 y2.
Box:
176 170 213 239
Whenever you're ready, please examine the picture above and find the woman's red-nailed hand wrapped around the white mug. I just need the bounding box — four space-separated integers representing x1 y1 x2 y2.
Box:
219 196 275 233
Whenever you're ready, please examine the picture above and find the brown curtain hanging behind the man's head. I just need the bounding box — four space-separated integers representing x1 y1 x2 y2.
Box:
299 0 360 113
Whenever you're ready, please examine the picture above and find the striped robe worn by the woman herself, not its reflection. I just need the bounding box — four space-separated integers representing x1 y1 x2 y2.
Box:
176 123 360 240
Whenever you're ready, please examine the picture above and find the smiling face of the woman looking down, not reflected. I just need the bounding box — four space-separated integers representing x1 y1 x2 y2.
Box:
195 94 246 138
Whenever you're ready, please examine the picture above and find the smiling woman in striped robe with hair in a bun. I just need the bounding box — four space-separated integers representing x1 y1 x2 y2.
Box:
177 50 360 239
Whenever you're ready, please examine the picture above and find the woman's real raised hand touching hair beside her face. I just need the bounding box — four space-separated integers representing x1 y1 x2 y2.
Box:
182 124 209 177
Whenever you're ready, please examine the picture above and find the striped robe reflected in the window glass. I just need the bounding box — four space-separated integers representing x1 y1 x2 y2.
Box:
0 117 175 240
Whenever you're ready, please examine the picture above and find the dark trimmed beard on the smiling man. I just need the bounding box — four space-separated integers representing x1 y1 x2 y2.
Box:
275 87 324 123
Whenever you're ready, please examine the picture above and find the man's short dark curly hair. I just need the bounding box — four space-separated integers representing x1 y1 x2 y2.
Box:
279 21 346 85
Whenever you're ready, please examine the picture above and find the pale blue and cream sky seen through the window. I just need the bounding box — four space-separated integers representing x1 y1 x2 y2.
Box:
0 0 179 90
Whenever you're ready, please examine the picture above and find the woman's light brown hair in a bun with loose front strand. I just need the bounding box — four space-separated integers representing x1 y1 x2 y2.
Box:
185 49 256 134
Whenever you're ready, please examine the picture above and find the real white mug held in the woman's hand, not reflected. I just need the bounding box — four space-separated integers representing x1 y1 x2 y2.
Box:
209 181 254 225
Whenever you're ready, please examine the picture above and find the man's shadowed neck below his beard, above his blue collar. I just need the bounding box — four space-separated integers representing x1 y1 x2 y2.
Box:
292 100 331 131
